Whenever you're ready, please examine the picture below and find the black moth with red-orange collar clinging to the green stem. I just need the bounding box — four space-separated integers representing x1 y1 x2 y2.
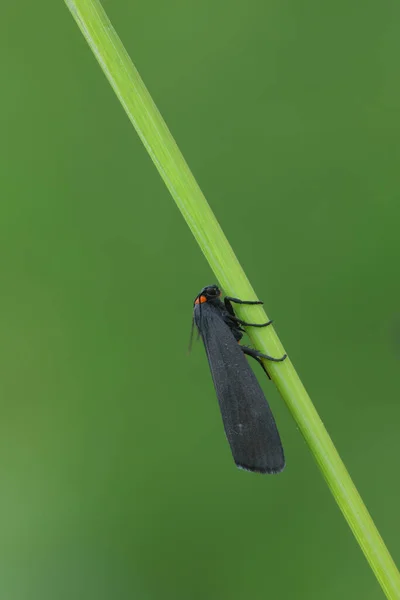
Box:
193 285 286 473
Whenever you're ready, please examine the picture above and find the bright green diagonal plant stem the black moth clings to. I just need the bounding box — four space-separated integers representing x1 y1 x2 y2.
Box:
65 0 400 599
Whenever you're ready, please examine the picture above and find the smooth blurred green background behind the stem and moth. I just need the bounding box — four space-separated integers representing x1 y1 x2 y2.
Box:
0 0 400 600
